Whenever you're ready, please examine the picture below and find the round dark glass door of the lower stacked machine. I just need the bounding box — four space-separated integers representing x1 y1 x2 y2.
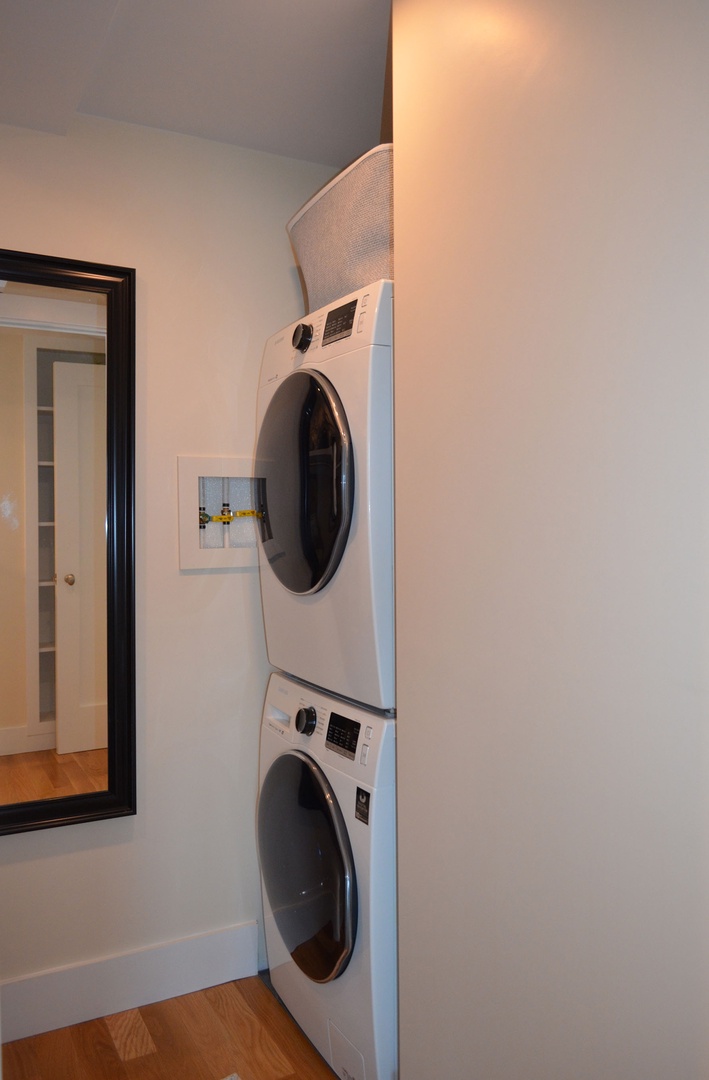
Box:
258 751 357 983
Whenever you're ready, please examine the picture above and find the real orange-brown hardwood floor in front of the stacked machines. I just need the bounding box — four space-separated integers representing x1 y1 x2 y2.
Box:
2 976 335 1080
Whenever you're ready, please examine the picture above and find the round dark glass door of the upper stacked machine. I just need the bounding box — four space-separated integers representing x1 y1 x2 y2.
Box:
256 369 355 595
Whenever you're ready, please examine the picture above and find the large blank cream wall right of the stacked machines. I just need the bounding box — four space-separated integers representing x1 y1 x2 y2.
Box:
393 0 709 1080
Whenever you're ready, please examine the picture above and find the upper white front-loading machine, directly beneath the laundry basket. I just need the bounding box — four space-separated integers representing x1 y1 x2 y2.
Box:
254 281 396 710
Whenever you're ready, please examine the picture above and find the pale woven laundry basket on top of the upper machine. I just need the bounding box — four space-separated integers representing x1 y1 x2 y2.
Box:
286 143 393 311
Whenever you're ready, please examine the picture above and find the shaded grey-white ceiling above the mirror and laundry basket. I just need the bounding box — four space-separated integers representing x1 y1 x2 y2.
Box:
0 0 391 167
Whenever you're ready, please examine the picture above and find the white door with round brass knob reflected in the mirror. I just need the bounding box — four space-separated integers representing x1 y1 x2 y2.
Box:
54 363 107 754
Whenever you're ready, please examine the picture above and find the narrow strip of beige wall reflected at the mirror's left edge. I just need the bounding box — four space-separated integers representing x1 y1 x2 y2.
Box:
0 330 26 728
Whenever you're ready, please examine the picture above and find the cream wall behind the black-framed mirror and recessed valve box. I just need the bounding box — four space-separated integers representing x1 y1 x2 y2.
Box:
0 118 331 1038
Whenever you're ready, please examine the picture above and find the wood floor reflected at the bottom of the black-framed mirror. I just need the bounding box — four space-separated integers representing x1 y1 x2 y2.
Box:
0 750 108 806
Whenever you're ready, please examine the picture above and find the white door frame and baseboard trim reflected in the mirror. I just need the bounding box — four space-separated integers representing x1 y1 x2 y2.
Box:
0 330 106 755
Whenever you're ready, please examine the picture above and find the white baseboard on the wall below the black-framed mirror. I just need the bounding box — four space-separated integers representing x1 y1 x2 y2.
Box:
0 922 258 1042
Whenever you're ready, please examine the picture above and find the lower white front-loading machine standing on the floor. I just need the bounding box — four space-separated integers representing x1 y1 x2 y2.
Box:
257 673 398 1080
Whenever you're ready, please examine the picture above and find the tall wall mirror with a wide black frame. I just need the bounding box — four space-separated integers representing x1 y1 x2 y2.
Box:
0 249 136 834
